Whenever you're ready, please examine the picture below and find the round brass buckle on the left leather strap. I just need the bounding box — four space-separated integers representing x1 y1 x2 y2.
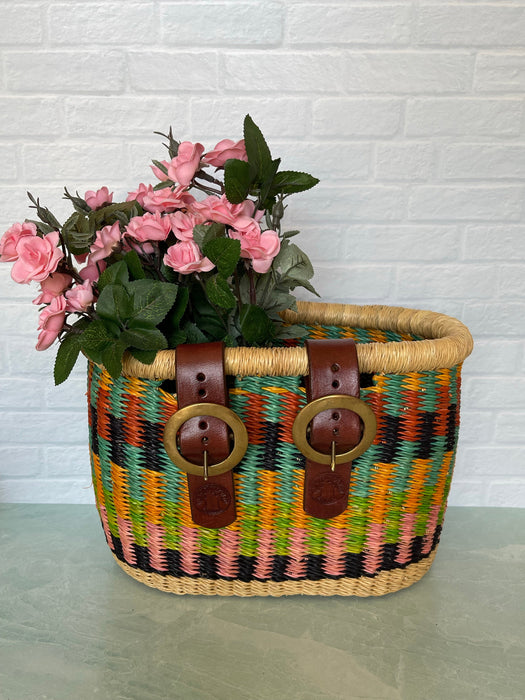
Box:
163 403 248 479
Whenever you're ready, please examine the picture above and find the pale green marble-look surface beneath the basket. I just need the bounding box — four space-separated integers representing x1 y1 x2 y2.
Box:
0 505 525 700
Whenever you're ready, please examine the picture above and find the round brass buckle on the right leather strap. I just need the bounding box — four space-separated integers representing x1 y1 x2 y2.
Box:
292 394 377 469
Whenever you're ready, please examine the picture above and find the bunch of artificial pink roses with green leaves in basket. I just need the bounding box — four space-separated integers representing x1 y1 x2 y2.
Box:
0 115 318 384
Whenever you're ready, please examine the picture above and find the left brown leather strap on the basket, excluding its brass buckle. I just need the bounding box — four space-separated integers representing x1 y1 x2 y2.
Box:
175 342 236 528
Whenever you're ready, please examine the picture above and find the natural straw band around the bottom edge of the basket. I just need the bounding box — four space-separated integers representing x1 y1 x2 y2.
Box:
112 550 436 598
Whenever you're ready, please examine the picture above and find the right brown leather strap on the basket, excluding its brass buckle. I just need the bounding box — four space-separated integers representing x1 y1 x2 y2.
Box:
304 339 361 519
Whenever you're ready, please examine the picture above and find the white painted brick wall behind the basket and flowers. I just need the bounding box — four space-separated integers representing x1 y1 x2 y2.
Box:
0 0 525 507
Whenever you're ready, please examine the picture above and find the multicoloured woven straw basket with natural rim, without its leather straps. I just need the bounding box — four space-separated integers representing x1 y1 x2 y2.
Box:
88 303 472 596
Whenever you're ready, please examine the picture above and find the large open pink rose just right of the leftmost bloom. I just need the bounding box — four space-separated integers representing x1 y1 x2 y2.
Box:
11 231 64 284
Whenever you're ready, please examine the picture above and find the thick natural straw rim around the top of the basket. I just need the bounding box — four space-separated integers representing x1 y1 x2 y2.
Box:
123 302 473 379
